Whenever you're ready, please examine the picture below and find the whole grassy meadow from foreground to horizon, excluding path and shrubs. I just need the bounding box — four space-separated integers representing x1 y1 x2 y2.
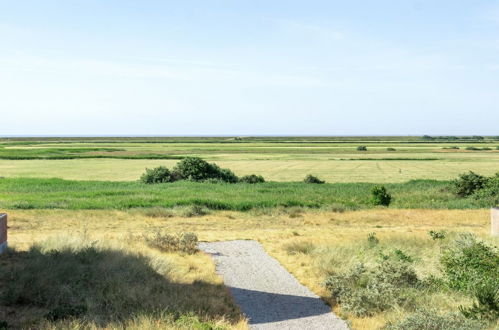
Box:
0 137 499 329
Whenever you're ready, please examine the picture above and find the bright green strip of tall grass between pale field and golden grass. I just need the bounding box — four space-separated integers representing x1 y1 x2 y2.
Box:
0 178 487 211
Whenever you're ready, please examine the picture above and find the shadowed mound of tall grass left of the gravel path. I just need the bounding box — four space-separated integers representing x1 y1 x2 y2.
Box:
0 237 240 329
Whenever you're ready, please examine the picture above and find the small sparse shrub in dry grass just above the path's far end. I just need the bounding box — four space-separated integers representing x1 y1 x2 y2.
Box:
144 231 198 254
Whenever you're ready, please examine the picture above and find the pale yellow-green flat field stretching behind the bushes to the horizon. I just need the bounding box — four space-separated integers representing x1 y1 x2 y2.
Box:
0 137 499 183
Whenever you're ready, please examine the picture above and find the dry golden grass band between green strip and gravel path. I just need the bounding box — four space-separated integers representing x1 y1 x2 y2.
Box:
3 208 498 329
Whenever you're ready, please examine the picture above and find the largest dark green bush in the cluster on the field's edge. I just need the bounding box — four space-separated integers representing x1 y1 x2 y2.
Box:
173 157 238 183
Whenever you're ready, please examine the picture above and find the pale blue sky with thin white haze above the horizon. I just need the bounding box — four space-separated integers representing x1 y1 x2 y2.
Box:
0 0 499 136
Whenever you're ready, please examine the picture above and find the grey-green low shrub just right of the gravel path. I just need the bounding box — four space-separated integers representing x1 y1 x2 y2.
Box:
325 259 419 317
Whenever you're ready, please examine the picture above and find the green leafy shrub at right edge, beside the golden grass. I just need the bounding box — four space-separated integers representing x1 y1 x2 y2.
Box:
440 233 499 292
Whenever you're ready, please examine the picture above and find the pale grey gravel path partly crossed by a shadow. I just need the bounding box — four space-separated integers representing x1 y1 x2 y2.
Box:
199 241 348 330
